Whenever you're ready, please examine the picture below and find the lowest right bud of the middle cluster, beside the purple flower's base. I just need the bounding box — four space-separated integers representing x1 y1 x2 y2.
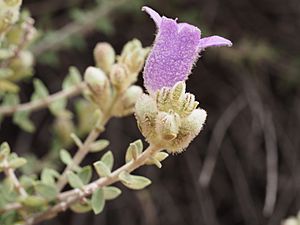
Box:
112 85 143 117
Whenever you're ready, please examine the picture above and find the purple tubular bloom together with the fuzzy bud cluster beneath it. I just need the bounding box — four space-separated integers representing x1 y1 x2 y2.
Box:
135 7 232 153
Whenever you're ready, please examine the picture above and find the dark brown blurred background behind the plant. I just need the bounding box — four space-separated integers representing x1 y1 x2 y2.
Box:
0 0 300 225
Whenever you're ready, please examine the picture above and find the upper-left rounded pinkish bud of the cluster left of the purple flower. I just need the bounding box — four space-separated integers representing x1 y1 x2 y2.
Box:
94 42 116 74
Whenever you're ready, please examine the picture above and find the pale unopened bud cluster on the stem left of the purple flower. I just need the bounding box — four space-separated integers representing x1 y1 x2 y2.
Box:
84 39 149 117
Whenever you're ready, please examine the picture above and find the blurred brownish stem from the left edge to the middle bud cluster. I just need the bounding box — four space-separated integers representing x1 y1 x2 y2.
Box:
0 82 86 116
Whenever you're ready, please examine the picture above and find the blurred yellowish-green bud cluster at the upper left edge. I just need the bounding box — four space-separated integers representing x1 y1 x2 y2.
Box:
0 9 37 93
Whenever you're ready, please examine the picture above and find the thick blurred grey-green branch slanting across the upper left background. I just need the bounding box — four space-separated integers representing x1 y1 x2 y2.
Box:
32 0 127 56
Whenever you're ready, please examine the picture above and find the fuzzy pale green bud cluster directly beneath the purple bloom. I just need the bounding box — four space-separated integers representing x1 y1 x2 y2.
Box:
135 82 206 153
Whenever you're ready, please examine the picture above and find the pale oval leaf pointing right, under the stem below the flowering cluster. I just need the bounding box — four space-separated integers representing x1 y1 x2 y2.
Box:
119 171 151 190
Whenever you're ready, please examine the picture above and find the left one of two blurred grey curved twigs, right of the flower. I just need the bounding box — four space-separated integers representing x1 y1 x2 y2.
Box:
198 96 247 187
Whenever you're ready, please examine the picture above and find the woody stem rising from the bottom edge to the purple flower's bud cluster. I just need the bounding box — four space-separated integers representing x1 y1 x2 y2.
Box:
26 145 161 225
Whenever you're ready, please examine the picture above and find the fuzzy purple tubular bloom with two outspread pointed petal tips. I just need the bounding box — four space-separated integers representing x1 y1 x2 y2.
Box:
142 6 232 93
